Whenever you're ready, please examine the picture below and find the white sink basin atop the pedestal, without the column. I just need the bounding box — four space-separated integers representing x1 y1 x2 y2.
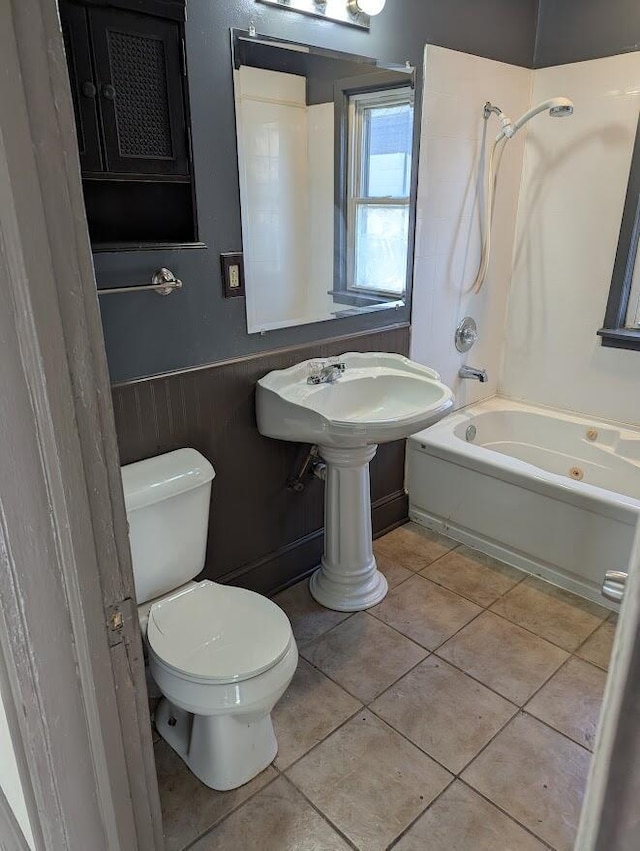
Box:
256 352 453 448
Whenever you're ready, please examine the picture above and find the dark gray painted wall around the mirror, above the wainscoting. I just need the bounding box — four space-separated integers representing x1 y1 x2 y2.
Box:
95 0 537 381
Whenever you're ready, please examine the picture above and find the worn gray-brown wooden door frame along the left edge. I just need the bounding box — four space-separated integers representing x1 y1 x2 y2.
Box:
0 0 163 851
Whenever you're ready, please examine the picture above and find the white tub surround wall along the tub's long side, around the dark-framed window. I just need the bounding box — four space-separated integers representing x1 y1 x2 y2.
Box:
502 52 640 423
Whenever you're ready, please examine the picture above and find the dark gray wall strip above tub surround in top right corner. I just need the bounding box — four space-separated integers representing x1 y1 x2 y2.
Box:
534 0 640 68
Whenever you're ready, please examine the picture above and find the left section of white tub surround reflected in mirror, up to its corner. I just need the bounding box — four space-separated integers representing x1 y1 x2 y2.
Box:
235 66 312 333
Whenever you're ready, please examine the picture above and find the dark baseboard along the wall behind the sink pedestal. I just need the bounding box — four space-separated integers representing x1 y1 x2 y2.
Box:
216 491 409 596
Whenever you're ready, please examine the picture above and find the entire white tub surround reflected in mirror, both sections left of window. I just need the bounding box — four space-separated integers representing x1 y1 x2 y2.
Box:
234 65 336 333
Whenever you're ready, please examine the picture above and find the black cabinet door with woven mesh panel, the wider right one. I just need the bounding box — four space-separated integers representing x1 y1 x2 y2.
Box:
89 9 189 175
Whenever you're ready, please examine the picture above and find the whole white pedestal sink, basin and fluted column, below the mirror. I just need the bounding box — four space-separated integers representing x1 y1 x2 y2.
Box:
256 352 453 612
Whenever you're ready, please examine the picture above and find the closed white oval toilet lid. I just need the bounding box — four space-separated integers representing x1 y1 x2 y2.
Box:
147 580 292 683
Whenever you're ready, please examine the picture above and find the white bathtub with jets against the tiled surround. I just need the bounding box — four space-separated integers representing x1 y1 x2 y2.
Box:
407 397 640 608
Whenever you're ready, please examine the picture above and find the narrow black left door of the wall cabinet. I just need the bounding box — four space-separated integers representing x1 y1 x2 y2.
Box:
60 0 104 171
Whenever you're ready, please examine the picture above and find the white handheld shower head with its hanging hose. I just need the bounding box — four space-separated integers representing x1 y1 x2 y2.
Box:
471 97 573 293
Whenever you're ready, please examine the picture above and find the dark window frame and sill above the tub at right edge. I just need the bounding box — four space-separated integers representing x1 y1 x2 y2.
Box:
598 115 640 351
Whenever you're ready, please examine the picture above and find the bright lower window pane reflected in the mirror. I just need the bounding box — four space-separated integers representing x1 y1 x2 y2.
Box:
353 204 409 295
